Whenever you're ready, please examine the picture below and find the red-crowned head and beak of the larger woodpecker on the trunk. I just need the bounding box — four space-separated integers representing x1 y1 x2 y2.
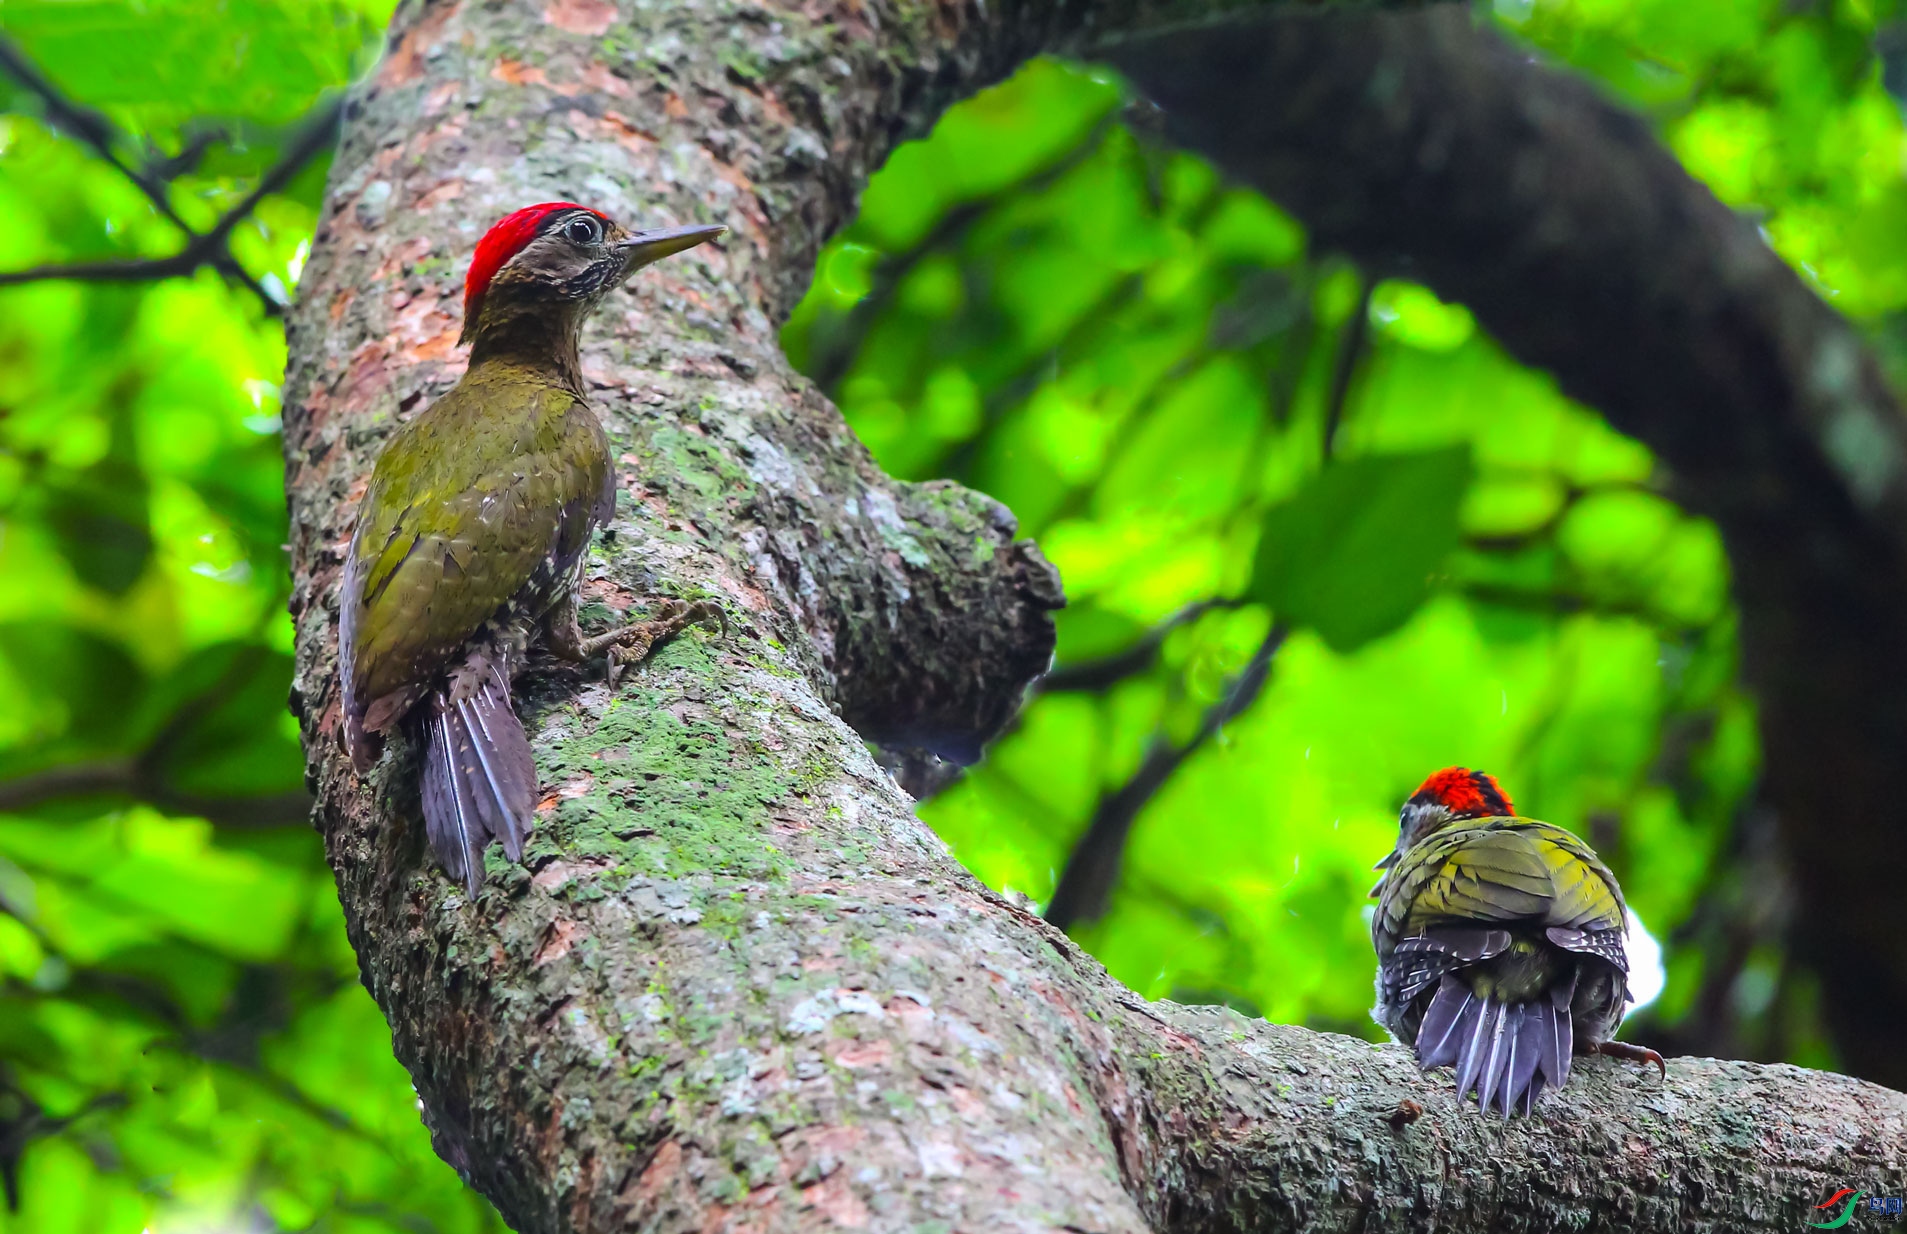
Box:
460 202 727 343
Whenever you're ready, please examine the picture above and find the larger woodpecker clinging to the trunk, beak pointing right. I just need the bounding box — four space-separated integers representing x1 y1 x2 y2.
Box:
338 202 723 896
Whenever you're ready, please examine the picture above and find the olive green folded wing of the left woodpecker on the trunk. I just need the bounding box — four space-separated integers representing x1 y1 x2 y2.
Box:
341 385 606 729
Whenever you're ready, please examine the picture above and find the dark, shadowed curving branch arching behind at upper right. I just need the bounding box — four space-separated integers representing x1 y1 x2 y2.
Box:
1110 6 1907 1089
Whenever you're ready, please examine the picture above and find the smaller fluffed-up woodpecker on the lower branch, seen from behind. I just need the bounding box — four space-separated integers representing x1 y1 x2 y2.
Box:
1371 767 1667 1118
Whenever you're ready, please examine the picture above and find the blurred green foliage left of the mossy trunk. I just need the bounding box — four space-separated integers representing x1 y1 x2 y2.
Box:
0 0 502 1234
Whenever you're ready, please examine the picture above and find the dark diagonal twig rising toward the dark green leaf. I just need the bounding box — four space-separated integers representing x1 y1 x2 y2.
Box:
1047 624 1285 929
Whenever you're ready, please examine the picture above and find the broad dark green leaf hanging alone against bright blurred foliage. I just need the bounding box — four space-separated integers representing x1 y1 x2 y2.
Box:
1251 446 1470 652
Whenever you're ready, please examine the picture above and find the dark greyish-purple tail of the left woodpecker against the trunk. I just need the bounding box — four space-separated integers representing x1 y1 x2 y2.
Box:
423 673 536 895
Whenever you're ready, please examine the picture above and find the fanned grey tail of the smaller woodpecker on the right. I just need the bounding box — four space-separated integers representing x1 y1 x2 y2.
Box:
1417 975 1575 1118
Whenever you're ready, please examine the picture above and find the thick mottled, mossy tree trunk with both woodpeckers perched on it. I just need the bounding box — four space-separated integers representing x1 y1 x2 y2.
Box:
286 0 1907 1232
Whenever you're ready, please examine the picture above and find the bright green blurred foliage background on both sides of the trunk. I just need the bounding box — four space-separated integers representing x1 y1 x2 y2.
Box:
0 0 1907 1234
